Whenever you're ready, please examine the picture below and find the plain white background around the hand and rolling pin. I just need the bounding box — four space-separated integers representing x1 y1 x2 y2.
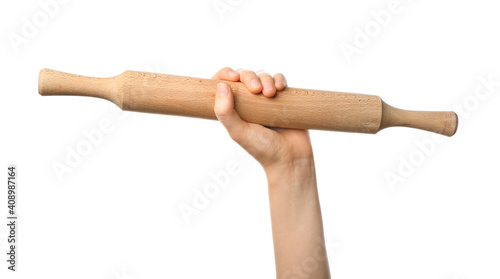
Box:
0 0 500 279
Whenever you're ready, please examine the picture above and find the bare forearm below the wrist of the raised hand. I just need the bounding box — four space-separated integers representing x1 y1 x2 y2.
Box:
266 158 330 279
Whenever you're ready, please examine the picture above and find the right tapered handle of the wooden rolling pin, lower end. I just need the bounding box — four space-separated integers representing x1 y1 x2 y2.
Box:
379 101 458 137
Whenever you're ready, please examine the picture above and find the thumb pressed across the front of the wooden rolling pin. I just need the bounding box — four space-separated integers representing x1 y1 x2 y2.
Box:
214 82 248 144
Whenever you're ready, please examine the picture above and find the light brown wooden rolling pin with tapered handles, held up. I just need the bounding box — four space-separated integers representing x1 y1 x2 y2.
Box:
38 69 458 136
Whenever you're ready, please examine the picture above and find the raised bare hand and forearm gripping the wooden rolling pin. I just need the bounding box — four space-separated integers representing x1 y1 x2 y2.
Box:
212 67 330 279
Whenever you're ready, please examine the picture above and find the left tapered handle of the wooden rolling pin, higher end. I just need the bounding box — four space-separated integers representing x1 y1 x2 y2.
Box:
38 69 122 107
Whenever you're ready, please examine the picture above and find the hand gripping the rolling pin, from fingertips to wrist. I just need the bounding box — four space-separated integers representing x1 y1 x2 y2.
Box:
212 67 313 172
